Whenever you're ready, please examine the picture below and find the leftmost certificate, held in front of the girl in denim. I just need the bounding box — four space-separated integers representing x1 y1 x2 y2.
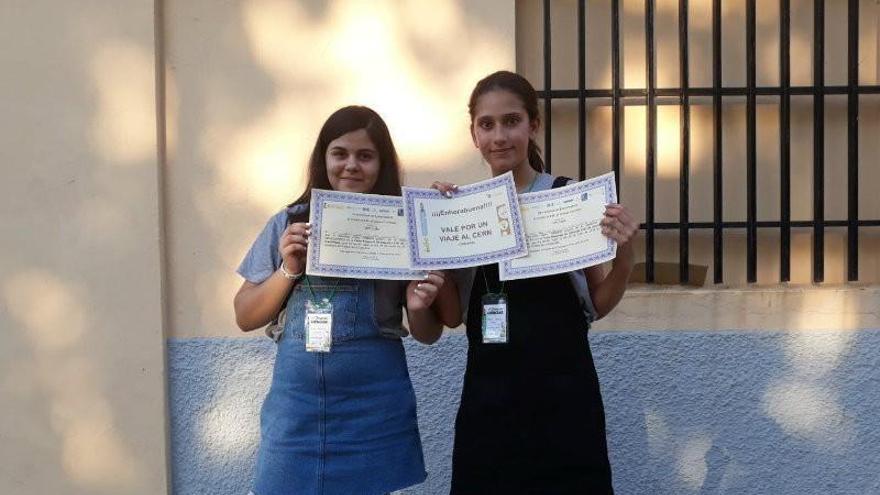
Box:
306 189 425 280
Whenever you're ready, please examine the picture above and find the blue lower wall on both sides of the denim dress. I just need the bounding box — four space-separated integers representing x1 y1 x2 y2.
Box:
168 334 467 495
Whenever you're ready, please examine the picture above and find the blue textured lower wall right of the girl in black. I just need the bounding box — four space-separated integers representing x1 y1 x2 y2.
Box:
593 331 880 495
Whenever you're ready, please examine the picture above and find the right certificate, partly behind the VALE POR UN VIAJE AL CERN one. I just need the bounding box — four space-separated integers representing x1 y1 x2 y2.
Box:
498 173 617 280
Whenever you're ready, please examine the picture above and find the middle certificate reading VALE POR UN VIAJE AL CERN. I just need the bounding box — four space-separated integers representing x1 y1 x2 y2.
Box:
403 172 528 270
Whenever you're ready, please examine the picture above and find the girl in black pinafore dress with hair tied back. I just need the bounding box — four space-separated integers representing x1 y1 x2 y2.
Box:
433 71 638 495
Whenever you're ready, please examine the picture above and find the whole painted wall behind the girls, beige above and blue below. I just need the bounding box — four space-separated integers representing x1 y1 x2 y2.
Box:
0 0 880 495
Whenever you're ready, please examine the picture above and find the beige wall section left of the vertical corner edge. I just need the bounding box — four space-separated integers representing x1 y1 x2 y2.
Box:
0 0 167 495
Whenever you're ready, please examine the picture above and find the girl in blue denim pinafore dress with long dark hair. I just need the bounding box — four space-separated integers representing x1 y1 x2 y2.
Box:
234 106 460 495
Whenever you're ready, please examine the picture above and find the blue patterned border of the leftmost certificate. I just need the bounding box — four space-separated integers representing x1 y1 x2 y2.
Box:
306 189 425 280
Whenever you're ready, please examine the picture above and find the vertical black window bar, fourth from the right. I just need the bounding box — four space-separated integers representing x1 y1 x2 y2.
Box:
746 0 758 284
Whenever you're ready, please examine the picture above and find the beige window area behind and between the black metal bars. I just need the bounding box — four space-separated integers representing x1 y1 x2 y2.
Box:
517 0 880 286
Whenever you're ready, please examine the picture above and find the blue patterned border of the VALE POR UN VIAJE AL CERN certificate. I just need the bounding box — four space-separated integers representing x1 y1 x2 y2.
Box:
403 172 528 270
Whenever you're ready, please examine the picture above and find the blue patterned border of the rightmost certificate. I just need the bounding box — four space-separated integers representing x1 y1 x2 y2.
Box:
499 172 617 280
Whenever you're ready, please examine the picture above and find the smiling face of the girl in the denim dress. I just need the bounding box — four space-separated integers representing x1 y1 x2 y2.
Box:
324 129 380 193
